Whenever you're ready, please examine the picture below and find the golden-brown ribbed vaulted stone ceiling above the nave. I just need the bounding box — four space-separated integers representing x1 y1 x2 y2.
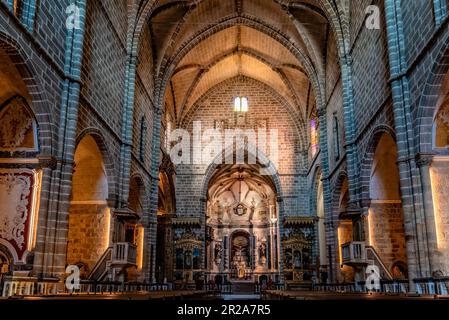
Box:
145 0 330 121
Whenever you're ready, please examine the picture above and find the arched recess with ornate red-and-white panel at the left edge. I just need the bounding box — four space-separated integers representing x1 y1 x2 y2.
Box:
0 95 42 270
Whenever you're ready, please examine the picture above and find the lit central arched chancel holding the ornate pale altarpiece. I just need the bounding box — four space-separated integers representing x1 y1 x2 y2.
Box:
206 164 280 282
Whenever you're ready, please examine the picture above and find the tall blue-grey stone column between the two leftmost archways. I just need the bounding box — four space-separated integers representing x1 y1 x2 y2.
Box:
35 0 86 277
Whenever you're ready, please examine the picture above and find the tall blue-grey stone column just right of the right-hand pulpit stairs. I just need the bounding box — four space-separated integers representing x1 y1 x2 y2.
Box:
384 0 430 291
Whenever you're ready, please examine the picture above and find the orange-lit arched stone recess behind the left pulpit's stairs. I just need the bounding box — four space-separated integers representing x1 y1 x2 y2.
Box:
66 135 111 277
